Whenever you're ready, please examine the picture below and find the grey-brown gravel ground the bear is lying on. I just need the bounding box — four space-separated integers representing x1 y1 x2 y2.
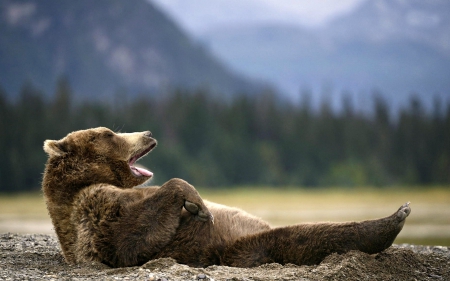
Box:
0 233 450 281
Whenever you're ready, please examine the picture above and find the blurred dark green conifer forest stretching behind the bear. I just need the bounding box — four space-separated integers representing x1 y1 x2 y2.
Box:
0 78 450 192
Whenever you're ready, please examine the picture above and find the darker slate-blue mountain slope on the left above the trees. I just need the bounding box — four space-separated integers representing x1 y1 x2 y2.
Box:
0 0 260 98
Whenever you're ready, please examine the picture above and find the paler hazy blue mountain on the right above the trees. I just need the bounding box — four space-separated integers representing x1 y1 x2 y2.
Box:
201 0 450 110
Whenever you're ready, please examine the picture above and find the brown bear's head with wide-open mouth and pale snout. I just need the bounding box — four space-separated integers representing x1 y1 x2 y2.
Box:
43 127 157 191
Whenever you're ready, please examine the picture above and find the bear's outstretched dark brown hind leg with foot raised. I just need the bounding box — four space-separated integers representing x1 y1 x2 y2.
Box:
221 203 411 267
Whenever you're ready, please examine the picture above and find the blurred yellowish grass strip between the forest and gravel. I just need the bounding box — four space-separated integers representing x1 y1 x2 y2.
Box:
0 187 450 246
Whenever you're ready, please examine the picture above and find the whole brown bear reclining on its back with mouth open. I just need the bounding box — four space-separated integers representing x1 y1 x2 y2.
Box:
42 128 411 267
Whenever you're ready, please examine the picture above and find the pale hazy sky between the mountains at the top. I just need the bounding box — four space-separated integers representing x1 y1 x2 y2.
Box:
150 0 366 35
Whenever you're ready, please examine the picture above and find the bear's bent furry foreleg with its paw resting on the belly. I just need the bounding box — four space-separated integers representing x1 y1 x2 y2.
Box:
108 179 213 266
